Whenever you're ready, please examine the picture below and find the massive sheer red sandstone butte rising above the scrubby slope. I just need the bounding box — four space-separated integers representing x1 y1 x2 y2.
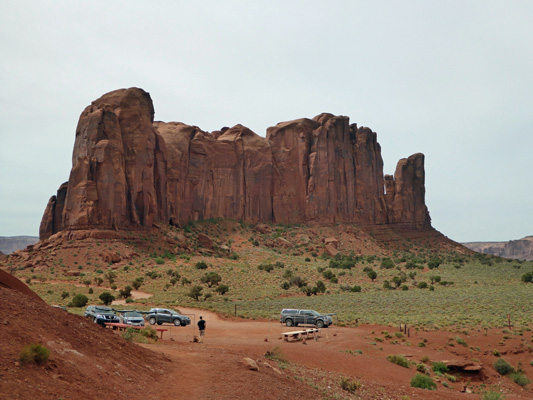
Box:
40 88 430 239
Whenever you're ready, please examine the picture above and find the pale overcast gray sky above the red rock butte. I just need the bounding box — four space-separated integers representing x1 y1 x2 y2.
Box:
0 0 533 241
